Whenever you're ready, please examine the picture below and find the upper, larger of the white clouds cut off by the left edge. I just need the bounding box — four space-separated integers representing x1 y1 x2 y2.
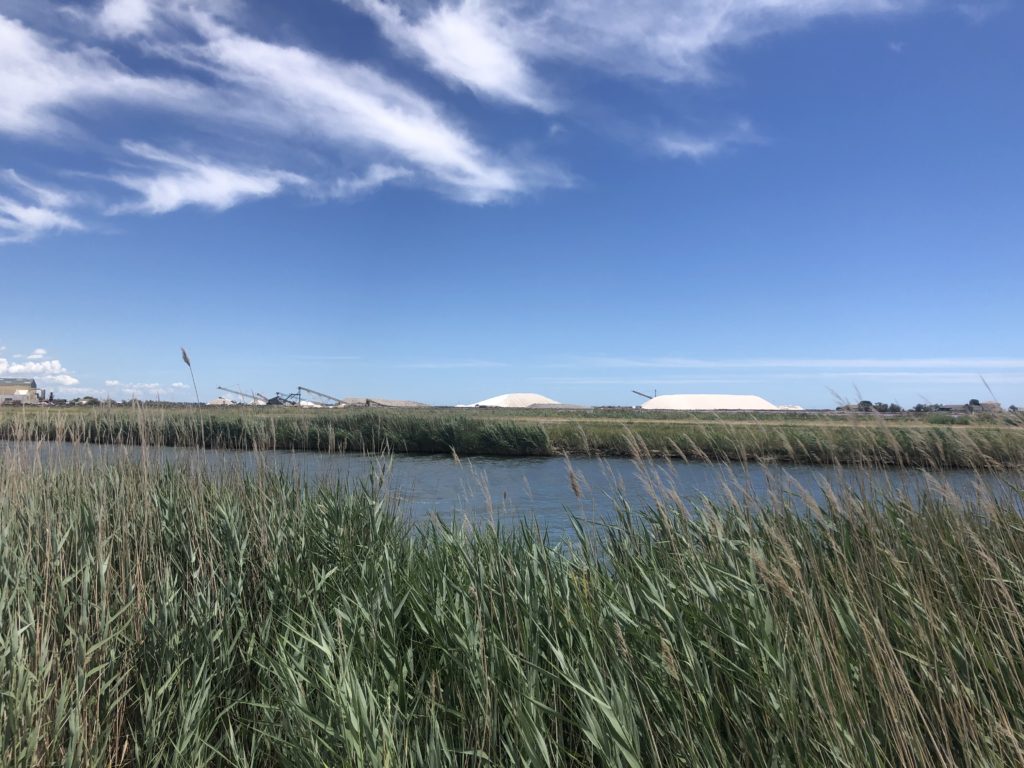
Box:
0 15 205 136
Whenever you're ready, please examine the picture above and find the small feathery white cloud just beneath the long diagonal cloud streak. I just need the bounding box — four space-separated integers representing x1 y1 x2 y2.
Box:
111 141 307 213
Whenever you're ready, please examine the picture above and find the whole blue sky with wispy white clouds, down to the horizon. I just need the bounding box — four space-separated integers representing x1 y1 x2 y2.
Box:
0 0 1024 407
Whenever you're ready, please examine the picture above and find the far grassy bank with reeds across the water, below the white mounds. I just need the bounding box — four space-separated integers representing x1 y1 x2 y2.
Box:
0 407 1024 468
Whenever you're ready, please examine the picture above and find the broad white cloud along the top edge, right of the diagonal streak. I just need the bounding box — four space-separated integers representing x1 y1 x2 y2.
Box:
343 0 925 111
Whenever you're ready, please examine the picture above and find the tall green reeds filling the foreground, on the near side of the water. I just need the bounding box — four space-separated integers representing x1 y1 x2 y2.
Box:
0 444 1024 768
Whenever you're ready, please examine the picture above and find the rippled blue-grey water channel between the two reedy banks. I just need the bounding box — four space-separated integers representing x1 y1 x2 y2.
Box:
0 442 1020 538
